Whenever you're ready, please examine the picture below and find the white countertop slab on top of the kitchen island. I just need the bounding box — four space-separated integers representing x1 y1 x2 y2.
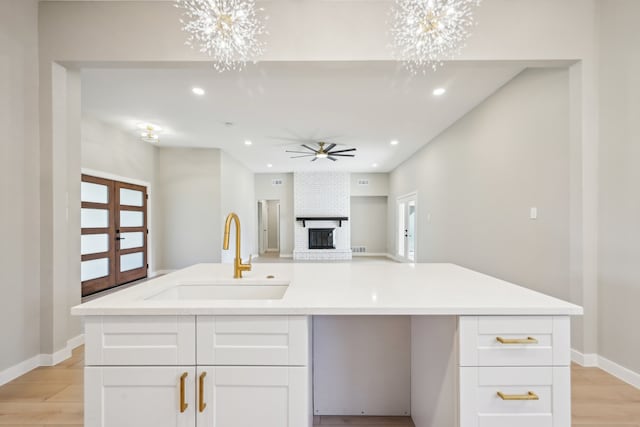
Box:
71 262 582 316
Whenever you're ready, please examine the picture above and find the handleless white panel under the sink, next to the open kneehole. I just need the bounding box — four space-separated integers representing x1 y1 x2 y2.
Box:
197 316 310 366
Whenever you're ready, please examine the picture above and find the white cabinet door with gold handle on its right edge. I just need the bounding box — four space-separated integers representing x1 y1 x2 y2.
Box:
84 366 197 427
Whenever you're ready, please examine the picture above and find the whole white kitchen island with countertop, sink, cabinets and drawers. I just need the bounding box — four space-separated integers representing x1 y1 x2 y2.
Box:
72 263 582 427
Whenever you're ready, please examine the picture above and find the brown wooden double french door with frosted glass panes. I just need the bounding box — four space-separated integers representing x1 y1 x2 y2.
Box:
80 175 148 296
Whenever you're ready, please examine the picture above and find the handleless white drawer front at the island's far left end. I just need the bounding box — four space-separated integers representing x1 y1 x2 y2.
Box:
85 316 196 366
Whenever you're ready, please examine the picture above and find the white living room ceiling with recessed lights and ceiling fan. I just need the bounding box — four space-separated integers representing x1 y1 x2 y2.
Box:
82 62 524 172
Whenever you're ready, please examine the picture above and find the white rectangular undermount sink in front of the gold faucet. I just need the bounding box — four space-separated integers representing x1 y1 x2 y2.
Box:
146 280 289 301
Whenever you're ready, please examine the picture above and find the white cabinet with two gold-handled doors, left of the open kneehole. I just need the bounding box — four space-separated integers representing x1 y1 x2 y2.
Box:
85 316 313 427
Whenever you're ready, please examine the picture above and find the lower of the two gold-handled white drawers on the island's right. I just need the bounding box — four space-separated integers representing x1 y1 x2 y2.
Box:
459 367 571 427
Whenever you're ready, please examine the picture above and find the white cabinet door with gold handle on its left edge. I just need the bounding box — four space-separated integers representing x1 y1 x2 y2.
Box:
196 366 313 427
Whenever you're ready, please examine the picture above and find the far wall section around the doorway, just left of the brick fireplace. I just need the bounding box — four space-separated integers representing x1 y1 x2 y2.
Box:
255 173 295 256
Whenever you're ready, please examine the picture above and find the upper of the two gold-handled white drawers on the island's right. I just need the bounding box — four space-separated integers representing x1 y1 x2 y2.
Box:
458 316 570 366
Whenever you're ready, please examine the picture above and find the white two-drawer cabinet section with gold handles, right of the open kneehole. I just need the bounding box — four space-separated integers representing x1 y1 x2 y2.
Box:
458 316 571 427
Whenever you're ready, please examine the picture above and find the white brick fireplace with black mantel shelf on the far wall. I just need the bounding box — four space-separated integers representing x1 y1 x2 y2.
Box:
293 172 351 260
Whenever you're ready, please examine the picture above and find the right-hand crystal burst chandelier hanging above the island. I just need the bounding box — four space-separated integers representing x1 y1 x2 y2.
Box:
391 0 480 73
